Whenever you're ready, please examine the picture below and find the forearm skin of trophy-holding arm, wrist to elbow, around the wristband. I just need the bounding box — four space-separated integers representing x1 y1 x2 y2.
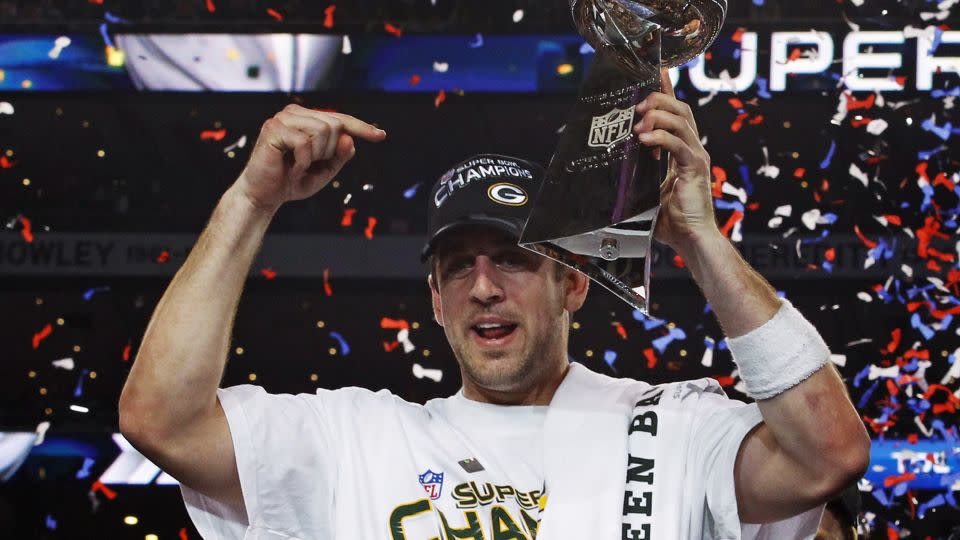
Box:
681 232 869 482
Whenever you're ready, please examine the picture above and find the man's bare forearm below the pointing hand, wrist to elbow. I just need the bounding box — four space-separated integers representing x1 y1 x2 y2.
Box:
120 188 273 430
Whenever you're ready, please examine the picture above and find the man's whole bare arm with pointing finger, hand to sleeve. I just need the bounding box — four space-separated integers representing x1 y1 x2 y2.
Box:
119 105 386 511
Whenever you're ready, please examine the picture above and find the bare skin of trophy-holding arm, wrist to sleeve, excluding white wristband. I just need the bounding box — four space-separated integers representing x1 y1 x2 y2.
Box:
681 231 870 523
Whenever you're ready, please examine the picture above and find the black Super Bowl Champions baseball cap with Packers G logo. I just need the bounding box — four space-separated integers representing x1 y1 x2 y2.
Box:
420 154 544 262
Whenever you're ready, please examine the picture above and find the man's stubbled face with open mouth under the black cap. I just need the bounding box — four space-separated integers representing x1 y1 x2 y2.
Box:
431 227 587 392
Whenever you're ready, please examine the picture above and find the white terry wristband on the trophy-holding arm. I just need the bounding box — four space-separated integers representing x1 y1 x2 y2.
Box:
727 298 830 399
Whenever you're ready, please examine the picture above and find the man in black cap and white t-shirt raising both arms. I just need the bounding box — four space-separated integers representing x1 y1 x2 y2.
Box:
120 69 869 540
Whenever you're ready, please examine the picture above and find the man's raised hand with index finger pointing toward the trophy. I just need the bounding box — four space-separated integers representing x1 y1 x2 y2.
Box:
236 104 387 211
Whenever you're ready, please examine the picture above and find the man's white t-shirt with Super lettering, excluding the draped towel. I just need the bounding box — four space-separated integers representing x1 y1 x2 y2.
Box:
181 370 822 540
